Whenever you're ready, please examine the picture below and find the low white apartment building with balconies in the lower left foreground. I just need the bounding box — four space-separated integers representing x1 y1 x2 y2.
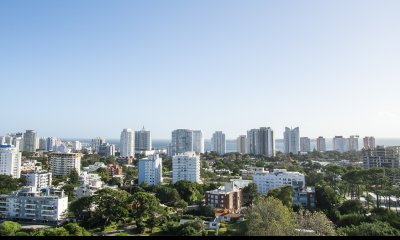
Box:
0 187 68 223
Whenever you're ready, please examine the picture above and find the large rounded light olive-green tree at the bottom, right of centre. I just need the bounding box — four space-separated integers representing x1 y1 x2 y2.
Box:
244 197 295 236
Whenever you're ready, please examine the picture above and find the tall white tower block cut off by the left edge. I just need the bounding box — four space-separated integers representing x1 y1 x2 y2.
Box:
0 145 21 178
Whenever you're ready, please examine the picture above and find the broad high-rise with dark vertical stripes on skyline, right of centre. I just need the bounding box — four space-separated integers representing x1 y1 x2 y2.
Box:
246 127 275 157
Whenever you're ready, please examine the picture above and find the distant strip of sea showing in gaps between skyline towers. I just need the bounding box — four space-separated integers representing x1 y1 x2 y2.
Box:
62 138 400 153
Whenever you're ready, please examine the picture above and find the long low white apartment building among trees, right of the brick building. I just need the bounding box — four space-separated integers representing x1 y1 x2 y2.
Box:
253 169 305 194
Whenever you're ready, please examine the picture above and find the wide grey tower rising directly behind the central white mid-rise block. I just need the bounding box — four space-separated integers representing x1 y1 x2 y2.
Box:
171 129 193 156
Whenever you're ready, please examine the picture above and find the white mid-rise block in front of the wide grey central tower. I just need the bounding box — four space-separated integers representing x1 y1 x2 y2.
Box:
172 152 201 183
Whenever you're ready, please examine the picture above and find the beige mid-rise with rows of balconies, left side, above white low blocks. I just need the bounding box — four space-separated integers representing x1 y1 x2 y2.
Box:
50 153 81 177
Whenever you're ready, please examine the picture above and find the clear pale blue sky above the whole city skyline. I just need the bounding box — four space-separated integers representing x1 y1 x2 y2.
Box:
0 0 400 139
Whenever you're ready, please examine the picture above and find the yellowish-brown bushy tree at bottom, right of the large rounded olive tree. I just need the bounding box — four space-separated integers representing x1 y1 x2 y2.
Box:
294 210 336 236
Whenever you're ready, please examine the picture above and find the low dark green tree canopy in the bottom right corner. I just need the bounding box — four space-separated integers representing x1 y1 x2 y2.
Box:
337 221 400 236
